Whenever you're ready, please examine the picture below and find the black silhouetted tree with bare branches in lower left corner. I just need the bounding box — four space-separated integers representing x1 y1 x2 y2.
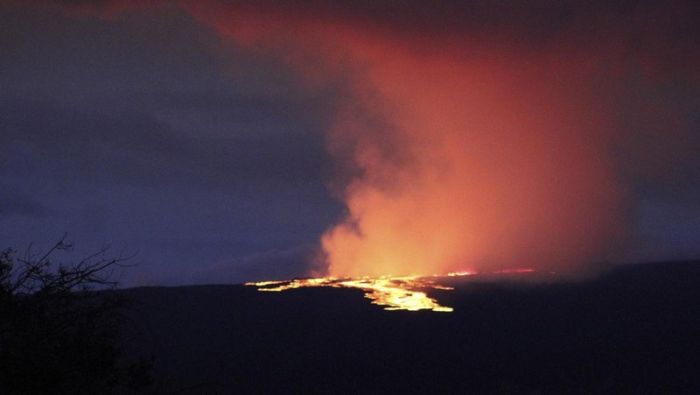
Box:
0 237 150 394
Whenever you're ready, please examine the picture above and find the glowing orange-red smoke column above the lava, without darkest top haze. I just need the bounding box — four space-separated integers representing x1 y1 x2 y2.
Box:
187 4 624 278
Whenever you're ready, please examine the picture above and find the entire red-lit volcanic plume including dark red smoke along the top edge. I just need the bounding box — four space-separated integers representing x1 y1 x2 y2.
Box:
41 1 700 276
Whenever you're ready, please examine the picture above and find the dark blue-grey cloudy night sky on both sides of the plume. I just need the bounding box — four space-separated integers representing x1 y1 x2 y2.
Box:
0 0 700 286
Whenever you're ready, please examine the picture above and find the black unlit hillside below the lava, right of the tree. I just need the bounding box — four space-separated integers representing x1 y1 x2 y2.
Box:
123 262 700 393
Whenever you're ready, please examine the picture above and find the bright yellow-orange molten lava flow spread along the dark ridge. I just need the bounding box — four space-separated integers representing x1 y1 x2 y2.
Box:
246 269 532 313
